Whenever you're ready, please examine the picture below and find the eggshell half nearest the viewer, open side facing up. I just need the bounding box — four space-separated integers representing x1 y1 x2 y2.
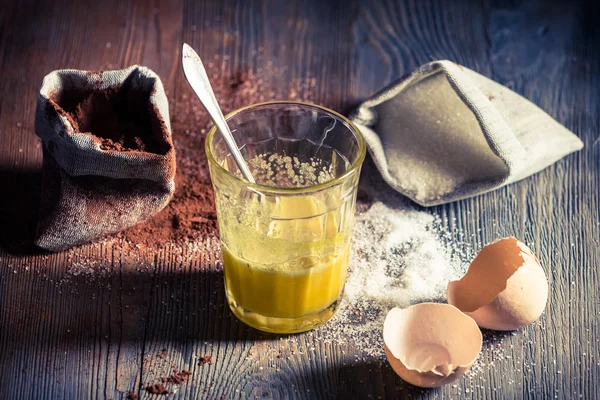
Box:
383 303 482 388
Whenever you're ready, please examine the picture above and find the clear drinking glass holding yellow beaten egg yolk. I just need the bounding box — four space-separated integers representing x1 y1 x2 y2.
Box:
206 101 366 333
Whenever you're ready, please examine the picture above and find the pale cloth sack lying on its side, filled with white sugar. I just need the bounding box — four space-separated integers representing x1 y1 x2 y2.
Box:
351 61 583 206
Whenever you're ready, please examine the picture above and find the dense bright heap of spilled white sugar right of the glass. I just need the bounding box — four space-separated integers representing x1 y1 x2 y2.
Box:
346 203 457 308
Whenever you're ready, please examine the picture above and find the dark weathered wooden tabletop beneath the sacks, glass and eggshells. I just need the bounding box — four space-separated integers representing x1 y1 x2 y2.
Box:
0 0 600 399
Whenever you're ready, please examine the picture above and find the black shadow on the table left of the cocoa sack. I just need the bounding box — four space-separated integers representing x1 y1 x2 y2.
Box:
0 166 42 255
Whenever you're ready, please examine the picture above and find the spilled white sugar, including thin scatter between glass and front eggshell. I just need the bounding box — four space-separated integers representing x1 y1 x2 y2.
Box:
313 202 474 359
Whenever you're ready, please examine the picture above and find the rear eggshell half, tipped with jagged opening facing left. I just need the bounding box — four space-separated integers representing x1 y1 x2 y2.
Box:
448 237 548 331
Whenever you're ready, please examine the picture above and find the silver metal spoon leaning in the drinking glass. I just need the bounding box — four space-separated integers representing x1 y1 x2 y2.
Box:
181 43 255 183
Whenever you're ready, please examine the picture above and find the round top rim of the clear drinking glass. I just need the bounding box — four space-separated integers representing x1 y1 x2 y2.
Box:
204 100 367 195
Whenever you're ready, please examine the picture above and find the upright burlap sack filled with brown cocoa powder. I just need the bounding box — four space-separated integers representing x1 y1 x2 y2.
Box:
35 66 175 251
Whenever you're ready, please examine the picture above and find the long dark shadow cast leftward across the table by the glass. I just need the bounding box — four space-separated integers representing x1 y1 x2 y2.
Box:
0 260 273 347
